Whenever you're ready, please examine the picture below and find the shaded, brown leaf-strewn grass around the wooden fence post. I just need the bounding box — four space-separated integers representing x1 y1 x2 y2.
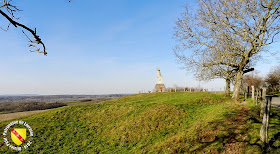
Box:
192 108 280 153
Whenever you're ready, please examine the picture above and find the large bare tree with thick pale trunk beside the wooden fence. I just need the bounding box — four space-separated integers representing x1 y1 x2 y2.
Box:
175 0 280 100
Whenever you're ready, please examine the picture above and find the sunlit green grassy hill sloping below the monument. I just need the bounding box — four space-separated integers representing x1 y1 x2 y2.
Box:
0 93 280 153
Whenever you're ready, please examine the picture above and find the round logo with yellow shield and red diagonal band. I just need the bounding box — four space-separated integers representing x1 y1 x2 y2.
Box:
3 120 33 151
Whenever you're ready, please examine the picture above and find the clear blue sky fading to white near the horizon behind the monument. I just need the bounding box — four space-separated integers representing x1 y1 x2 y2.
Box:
0 0 277 95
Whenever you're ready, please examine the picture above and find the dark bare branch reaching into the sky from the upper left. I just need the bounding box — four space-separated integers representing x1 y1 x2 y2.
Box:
0 0 70 55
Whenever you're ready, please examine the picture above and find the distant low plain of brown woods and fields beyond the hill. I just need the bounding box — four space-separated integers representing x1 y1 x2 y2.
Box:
0 94 129 114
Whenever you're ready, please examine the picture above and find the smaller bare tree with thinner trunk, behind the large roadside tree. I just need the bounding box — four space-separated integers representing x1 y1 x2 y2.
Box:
174 16 253 96
